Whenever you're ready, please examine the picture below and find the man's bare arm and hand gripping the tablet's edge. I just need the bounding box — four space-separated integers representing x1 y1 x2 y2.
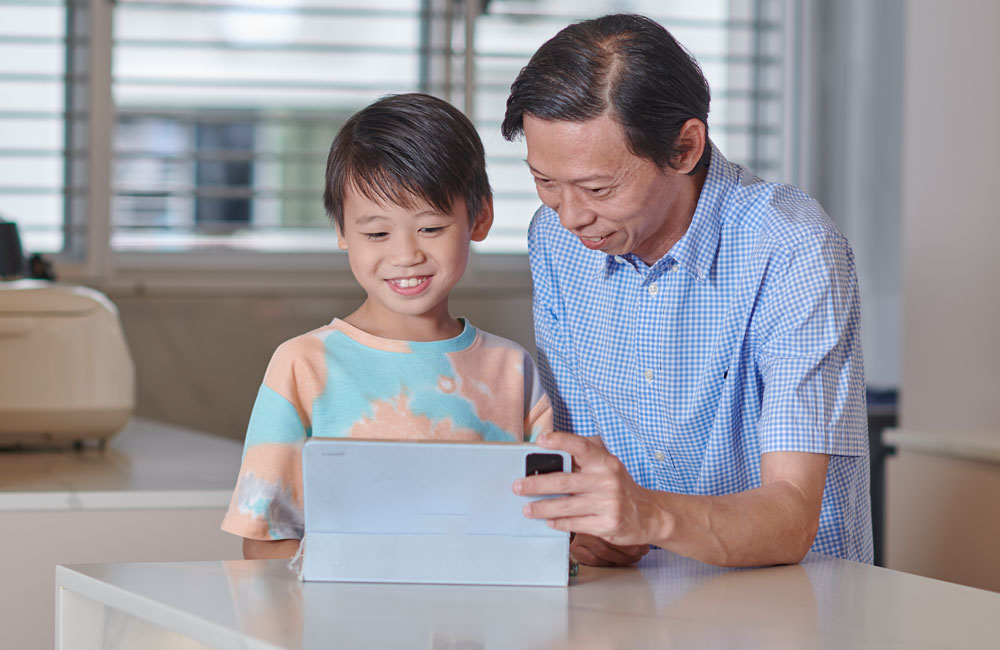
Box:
514 433 829 566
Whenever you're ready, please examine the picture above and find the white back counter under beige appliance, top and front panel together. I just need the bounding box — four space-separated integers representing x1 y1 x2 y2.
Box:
0 418 242 649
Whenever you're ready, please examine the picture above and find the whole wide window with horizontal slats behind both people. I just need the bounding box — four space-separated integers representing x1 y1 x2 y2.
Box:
0 0 795 264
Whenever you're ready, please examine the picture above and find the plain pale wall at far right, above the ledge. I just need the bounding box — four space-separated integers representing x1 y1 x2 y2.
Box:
900 0 1000 436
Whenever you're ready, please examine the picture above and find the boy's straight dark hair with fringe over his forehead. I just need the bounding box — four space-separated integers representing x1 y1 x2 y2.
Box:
323 93 493 232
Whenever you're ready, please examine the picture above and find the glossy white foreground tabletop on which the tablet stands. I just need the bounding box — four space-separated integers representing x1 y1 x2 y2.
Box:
57 551 1000 650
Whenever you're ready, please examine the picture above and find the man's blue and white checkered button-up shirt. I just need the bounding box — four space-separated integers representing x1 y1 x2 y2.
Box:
528 146 873 563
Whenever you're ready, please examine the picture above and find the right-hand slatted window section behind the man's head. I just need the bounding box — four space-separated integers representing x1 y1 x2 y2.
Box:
475 0 787 252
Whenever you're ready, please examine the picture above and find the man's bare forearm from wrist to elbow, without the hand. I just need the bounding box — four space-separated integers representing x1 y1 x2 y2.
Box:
650 481 819 566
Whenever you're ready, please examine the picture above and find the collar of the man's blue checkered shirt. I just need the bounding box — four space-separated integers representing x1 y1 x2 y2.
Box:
602 140 738 282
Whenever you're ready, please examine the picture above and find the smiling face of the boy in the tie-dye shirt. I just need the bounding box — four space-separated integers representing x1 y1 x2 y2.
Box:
337 186 493 332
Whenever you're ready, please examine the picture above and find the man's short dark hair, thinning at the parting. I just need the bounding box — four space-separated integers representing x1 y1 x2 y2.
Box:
501 14 711 174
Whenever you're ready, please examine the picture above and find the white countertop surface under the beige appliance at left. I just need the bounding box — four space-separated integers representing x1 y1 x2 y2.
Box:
0 418 242 512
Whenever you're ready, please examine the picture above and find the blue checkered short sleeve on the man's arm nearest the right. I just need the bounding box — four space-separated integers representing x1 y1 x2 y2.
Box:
757 231 868 456
